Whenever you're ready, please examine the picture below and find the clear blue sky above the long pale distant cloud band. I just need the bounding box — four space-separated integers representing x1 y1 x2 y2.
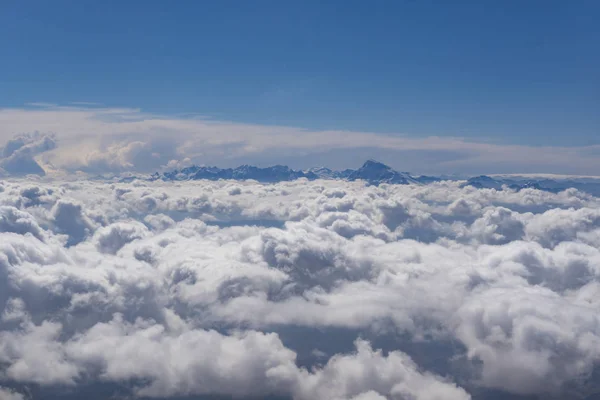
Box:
0 0 600 173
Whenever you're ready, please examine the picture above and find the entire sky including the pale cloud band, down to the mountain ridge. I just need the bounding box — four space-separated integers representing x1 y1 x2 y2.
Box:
0 0 600 174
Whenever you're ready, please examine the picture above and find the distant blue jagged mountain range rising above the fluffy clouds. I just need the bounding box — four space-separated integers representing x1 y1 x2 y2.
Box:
150 160 600 196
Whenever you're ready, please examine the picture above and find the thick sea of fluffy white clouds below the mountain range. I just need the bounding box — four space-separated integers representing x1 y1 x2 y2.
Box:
0 180 600 400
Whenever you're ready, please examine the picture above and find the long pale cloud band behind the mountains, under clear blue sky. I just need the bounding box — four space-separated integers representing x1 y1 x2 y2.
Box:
0 105 600 175
